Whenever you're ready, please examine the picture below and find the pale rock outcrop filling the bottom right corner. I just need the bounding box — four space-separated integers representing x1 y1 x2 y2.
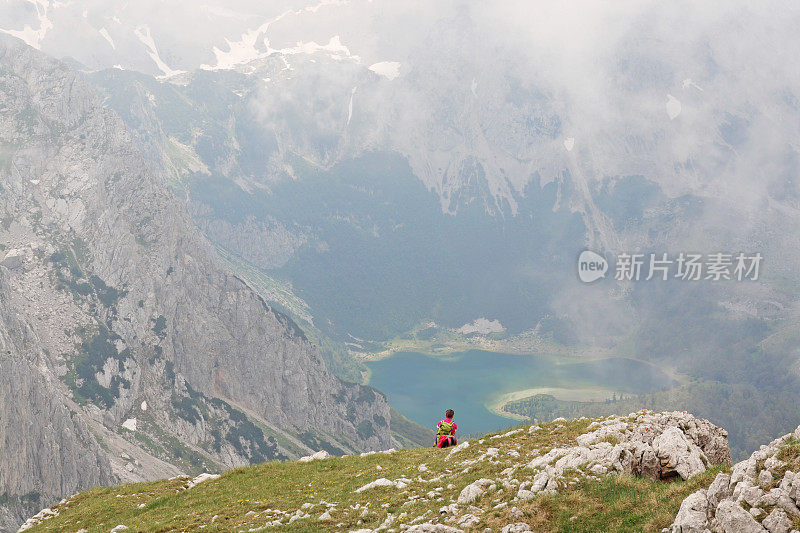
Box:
664 427 800 533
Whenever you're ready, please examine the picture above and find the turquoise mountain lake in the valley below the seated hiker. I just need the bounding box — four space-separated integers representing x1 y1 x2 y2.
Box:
368 350 673 435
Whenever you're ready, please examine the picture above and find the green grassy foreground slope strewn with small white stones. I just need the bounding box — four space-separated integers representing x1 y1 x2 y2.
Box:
23 419 723 533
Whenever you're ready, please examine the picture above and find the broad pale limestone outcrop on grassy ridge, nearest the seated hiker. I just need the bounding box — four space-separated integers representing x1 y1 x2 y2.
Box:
355 411 728 531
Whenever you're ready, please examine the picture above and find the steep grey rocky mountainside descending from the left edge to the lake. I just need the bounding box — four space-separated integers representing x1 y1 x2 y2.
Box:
0 37 391 529
